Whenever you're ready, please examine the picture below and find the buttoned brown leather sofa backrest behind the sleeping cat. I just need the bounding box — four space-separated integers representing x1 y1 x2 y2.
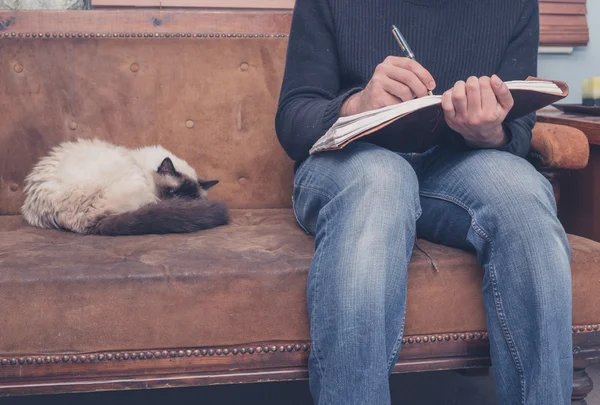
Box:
0 10 293 215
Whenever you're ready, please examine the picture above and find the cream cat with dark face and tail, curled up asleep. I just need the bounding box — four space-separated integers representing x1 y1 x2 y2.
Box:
21 139 229 236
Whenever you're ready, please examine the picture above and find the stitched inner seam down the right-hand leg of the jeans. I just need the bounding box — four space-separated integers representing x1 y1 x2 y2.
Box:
419 190 525 404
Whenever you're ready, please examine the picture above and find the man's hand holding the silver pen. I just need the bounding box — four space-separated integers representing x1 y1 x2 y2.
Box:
340 56 435 116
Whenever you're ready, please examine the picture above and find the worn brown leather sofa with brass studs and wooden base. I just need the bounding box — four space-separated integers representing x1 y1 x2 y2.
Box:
0 10 600 404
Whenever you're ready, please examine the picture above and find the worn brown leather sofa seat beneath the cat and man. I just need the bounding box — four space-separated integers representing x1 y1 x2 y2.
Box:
0 209 600 355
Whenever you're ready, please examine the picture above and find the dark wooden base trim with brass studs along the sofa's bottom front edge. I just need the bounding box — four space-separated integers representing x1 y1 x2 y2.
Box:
0 325 600 397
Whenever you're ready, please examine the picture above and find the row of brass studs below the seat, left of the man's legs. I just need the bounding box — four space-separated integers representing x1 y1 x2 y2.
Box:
0 344 309 366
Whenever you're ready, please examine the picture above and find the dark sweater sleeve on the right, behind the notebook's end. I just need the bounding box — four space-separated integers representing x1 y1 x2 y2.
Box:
498 0 540 157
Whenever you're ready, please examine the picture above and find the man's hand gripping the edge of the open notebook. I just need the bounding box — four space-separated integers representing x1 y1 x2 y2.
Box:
442 75 514 148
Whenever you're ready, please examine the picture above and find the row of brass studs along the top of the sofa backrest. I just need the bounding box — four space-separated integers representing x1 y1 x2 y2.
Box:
0 32 289 38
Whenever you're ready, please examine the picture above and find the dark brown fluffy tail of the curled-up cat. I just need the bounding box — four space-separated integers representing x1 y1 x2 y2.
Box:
88 198 229 236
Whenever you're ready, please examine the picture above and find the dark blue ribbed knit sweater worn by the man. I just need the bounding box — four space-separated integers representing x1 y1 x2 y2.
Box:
275 0 539 162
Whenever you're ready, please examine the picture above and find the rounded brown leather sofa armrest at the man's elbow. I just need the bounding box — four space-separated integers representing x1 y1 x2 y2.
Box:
530 122 590 169
